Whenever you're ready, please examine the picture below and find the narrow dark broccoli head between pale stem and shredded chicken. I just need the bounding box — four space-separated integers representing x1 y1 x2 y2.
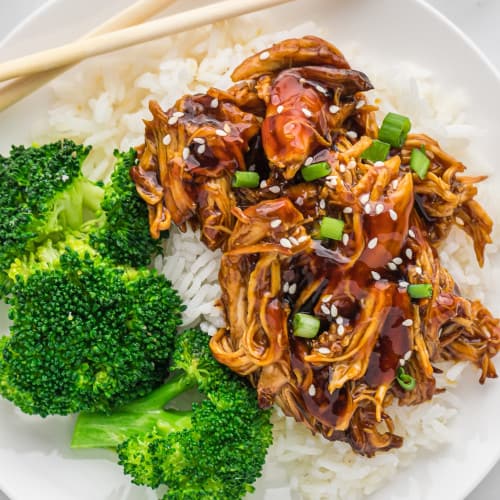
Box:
87 149 168 266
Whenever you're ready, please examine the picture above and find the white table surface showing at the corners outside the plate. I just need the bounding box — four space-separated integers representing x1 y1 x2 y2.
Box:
0 0 500 500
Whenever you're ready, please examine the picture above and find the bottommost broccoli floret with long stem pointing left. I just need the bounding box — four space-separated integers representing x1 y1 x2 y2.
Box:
72 330 272 500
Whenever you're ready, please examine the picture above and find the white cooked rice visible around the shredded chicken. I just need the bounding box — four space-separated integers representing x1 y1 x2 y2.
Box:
37 12 500 500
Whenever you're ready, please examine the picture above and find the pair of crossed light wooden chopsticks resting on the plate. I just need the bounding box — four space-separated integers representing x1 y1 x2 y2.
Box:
0 0 291 111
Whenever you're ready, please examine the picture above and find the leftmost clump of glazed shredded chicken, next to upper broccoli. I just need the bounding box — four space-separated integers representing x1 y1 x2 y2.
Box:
131 95 259 249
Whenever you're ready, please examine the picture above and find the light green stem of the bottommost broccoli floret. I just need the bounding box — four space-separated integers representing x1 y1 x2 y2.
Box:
71 373 197 448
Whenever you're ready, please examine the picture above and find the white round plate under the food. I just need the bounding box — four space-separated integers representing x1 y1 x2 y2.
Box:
0 0 500 500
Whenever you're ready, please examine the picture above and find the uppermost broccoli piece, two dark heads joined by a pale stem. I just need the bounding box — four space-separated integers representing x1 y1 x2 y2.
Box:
0 140 166 297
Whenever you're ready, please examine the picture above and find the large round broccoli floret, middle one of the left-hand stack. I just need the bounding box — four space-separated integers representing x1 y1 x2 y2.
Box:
0 236 184 416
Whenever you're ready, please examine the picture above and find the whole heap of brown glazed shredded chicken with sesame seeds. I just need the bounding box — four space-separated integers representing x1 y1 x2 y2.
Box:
132 37 500 456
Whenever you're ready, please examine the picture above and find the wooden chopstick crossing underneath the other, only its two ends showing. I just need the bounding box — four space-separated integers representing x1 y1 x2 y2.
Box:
0 0 175 111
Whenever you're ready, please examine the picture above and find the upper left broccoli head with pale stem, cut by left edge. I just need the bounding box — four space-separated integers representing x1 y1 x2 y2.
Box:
0 140 96 296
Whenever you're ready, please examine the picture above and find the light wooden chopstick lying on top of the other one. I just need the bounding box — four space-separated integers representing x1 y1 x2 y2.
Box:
0 0 291 85
